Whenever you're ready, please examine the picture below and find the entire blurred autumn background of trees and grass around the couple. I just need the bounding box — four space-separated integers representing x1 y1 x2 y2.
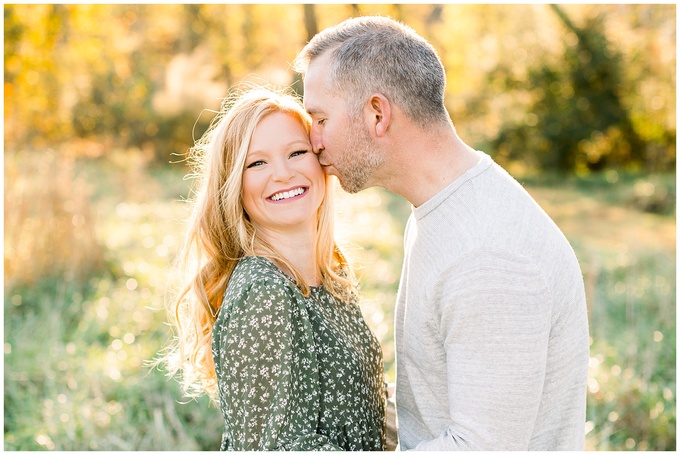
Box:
4 4 676 450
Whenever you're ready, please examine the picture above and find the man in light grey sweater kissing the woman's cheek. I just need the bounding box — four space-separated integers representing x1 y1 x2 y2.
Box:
296 17 589 450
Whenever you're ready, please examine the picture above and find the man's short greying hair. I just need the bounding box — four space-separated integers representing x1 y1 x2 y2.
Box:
294 16 451 126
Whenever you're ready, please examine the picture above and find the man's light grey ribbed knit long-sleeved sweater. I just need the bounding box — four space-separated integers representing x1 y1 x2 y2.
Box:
395 152 589 450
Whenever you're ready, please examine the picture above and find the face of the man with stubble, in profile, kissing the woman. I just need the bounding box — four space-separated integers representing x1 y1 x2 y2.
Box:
304 54 384 193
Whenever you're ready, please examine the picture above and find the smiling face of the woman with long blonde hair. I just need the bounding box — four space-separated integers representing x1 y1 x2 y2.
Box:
243 112 326 237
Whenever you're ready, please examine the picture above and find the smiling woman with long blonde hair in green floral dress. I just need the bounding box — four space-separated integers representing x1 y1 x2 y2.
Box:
162 89 385 450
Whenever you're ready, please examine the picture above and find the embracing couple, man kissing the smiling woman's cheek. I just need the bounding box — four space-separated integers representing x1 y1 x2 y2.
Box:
161 17 589 451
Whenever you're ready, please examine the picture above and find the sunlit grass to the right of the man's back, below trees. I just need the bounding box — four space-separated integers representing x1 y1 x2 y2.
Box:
523 173 676 451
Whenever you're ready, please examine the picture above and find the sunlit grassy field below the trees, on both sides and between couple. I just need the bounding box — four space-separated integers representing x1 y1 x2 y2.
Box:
4 151 676 450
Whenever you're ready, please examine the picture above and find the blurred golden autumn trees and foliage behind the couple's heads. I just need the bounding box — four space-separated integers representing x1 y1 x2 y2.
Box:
4 4 676 172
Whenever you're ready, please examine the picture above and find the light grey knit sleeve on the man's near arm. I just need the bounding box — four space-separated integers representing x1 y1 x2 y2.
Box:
416 251 552 450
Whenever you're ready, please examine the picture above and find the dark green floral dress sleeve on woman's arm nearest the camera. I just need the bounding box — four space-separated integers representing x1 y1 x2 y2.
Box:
215 280 340 451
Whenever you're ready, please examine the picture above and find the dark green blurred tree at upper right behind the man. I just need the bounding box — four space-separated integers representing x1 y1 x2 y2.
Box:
491 5 674 172
